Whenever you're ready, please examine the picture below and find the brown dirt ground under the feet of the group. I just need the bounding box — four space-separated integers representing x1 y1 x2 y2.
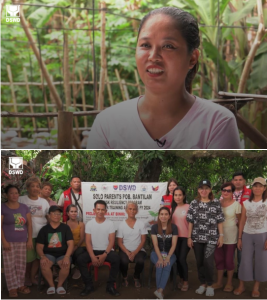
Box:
1 250 267 299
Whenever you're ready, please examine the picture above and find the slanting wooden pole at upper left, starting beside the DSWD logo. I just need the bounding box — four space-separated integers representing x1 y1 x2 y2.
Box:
20 5 62 110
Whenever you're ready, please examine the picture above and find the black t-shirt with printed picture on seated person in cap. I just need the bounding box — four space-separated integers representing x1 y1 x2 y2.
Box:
36 223 73 257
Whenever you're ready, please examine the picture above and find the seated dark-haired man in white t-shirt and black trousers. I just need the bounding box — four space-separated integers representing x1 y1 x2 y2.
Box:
76 200 120 296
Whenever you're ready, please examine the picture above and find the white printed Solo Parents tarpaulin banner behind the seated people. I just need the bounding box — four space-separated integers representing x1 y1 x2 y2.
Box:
82 182 167 230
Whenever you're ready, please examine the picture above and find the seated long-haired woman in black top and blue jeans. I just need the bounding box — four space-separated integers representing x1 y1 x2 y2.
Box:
150 206 178 299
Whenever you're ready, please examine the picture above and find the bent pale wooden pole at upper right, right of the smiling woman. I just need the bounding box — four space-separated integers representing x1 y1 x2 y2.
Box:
237 0 267 93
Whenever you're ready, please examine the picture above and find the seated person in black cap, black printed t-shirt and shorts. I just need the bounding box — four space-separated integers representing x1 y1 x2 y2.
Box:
36 205 74 295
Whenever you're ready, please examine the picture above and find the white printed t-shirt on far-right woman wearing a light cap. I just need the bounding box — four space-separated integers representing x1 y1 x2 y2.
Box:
243 200 267 234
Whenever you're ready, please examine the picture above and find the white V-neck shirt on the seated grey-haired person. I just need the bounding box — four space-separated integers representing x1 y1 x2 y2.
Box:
116 220 147 251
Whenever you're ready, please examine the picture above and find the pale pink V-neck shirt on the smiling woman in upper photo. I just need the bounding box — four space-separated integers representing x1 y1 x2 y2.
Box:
87 97 241 149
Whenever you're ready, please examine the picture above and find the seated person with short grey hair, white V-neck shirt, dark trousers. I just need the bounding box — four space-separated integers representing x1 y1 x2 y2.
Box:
117 202 147 288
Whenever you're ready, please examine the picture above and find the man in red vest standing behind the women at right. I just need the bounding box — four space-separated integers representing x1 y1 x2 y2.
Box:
232 172 251 278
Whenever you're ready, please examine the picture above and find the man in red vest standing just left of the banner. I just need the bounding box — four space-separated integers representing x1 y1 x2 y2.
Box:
58 176 83 222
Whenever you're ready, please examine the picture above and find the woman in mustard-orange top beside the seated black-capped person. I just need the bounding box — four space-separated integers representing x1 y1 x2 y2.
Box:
66 204 87 279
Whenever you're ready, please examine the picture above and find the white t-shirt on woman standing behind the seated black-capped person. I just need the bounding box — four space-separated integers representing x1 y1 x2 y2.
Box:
19 195 50 238
